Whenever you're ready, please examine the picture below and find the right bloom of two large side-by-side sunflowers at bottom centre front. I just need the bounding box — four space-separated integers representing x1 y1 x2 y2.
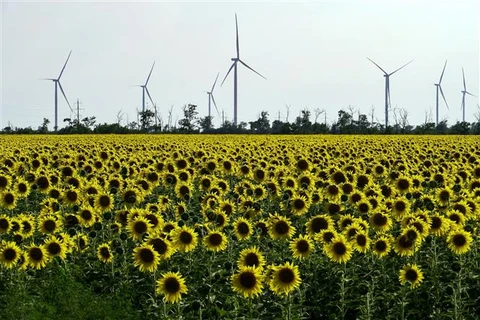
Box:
269 262 302 295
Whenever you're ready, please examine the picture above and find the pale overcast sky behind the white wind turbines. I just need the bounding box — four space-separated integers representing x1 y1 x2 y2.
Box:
0 0 480 129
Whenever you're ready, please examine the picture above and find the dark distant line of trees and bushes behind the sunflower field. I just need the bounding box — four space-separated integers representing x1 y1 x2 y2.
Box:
1 104 480 135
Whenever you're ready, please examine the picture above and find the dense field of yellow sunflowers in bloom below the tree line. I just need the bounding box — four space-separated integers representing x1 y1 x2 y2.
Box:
0 135 480 319
